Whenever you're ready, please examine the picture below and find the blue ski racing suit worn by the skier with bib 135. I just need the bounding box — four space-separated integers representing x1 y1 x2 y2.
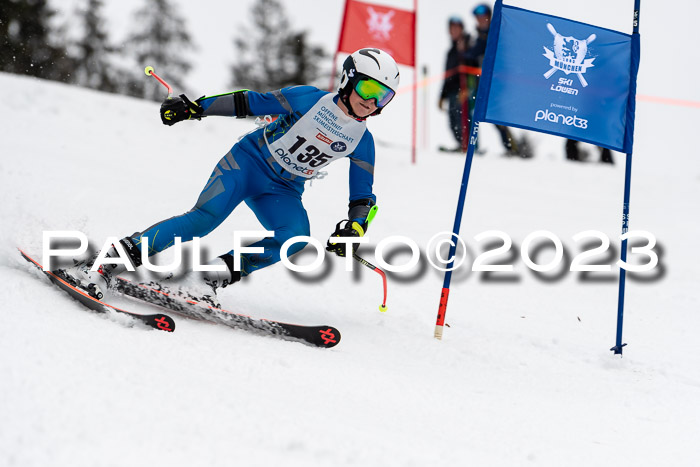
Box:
131 86 376 276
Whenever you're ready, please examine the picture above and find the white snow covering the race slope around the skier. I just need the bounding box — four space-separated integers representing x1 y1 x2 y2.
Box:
0 1 700 467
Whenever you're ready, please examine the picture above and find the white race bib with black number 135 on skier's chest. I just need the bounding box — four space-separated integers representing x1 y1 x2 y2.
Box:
265 94 366 178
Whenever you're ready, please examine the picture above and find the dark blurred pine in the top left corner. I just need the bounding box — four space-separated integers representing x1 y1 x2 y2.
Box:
0 0 72 81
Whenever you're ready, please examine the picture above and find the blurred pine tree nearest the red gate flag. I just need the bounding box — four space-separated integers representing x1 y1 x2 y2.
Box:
231 0 327 91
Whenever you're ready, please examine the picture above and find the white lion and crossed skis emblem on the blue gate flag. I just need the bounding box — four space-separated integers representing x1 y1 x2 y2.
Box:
542 23 596 88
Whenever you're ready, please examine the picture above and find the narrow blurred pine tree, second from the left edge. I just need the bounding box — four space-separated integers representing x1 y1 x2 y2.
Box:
72 0 119 92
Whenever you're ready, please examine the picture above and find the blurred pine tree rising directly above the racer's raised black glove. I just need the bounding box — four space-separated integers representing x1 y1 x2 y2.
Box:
126 0 195 100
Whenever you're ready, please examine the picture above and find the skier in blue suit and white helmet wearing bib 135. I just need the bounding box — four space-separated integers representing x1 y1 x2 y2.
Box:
59 48 399 307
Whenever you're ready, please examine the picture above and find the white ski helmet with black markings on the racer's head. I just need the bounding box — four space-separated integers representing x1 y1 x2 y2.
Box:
338 48 399 118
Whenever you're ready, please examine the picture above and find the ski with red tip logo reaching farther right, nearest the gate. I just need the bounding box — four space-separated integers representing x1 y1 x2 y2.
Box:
114 277 340 348
